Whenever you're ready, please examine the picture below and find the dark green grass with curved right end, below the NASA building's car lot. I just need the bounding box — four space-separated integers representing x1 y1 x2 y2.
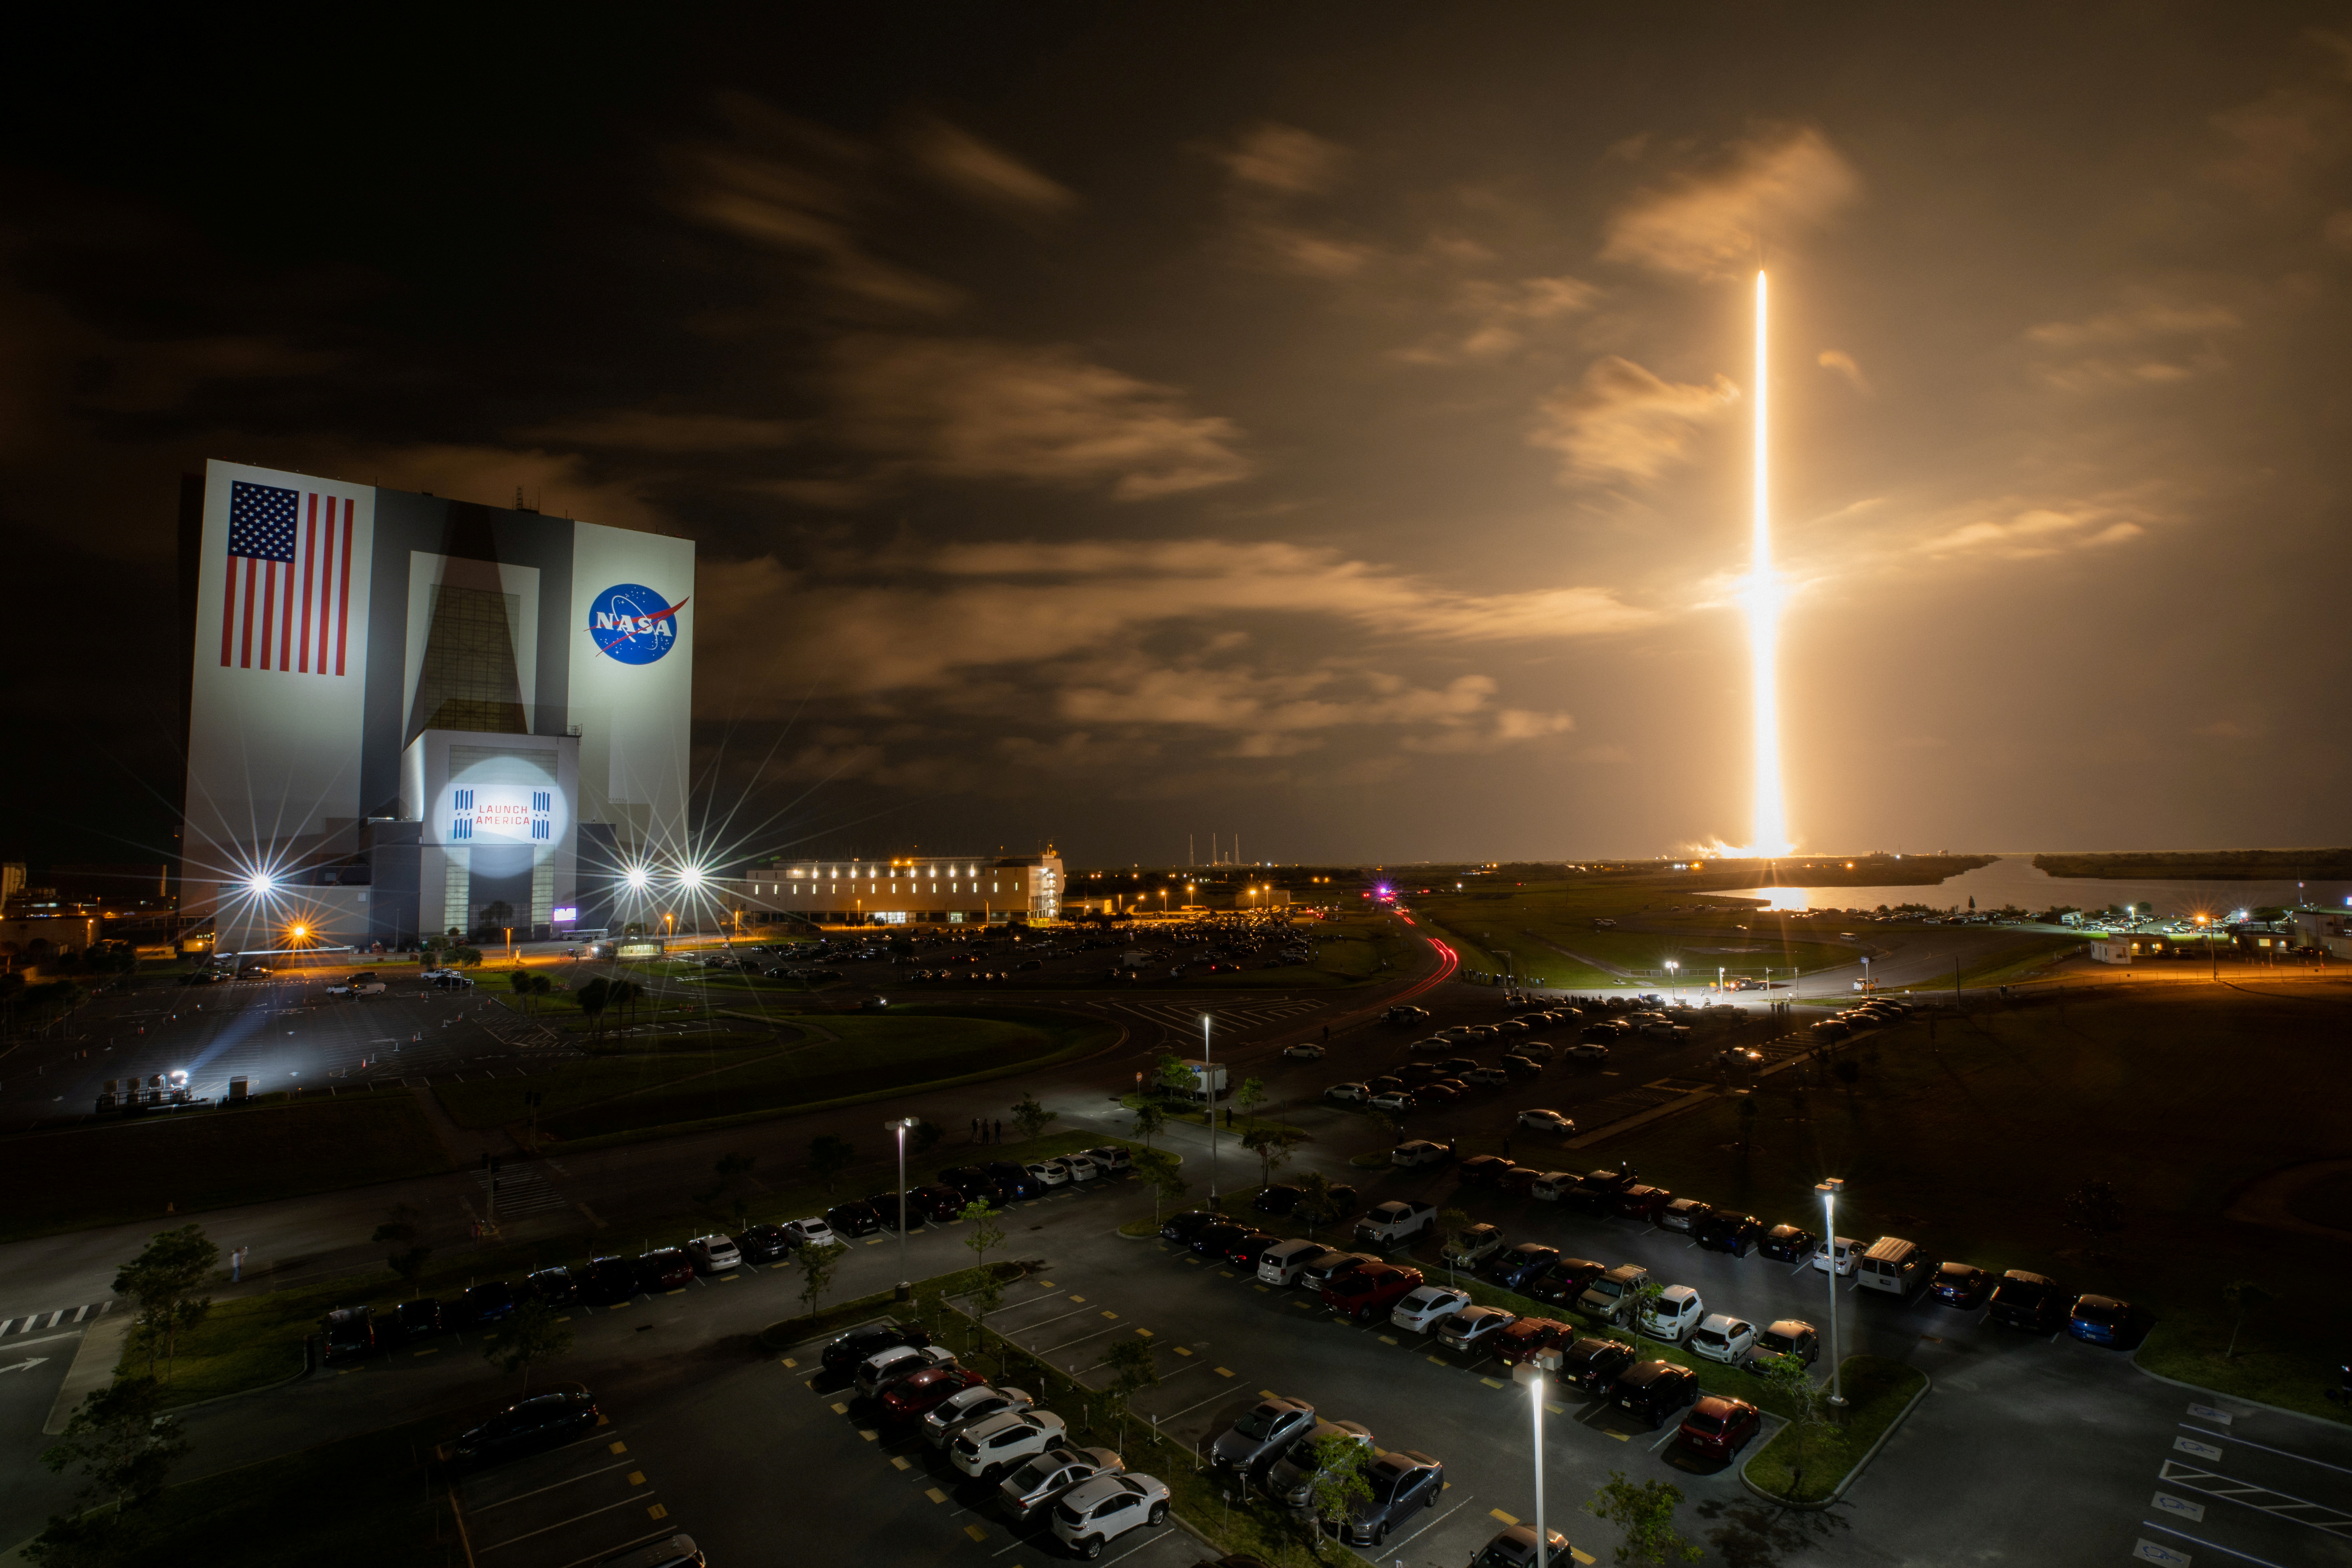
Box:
433 1008 1113 1145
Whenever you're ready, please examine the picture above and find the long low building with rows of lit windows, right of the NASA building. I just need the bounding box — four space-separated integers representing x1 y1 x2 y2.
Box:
710 851 1063 926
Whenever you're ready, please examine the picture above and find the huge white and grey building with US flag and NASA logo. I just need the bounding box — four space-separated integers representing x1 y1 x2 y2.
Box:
181 461 694 952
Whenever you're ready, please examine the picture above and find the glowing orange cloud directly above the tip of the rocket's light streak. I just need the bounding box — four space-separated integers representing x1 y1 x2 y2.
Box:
1602 129 1861 278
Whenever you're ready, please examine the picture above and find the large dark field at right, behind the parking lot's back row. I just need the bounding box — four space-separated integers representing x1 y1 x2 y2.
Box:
1595 985 2352 1415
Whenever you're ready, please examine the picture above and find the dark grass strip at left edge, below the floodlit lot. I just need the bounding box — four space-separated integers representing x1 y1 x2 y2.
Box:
0 1091 449 1241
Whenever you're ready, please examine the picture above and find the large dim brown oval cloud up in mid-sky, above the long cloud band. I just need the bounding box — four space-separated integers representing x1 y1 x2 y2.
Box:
835 336 1251 501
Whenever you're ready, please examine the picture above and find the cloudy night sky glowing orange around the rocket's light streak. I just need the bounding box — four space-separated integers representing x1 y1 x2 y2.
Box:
0 5 2352 863
